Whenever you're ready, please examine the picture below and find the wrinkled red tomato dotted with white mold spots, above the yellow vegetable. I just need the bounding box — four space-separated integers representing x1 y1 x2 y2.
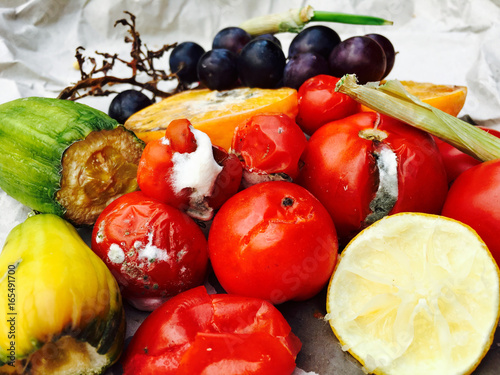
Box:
92 191 208 311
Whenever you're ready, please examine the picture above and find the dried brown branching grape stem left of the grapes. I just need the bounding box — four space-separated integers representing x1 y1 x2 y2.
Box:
58 11 185 100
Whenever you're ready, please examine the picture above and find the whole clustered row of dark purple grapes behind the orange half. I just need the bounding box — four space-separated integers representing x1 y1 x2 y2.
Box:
170 25 395 90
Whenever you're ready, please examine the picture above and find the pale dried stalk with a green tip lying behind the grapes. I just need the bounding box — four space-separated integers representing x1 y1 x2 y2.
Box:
239 5 392 36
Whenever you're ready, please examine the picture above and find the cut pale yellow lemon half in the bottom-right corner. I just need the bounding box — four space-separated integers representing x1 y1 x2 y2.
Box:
327 213 500 375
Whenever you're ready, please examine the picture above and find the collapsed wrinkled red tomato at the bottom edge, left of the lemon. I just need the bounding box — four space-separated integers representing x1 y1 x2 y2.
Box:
122 287 301 375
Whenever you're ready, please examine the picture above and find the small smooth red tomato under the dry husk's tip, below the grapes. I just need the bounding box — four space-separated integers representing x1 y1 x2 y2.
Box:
295 74 360 135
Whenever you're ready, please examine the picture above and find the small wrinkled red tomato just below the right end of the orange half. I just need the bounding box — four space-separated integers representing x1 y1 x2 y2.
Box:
231 114 307 187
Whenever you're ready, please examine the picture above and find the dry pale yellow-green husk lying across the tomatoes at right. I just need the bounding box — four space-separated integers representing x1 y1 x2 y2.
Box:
336 74 500 161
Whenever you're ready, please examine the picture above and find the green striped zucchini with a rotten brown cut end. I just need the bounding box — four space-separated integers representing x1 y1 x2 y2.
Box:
0 97 144 225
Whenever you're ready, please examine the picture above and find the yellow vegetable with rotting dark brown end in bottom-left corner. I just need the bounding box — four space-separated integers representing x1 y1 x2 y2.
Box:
0 214 125 374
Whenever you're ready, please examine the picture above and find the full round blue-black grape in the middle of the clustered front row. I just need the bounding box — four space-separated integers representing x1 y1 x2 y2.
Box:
238 39 286 88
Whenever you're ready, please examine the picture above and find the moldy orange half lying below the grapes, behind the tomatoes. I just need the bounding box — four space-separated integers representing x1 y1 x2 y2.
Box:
125 87 298 149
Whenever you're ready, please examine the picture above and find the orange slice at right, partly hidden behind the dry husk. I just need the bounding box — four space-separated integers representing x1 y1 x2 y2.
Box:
362 81 467 116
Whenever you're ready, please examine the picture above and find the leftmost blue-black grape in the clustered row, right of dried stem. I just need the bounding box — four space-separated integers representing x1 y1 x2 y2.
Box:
169 42 205 83
